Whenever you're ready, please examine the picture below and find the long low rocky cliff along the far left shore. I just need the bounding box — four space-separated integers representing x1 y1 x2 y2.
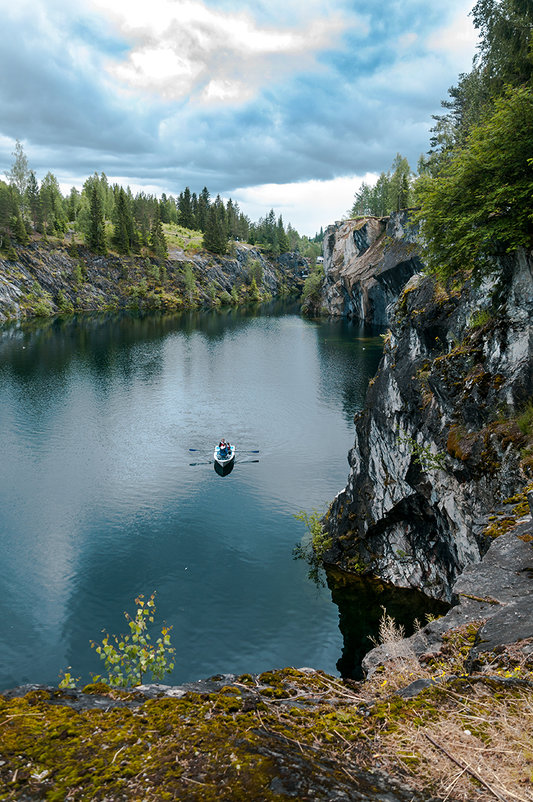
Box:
0 241 307 323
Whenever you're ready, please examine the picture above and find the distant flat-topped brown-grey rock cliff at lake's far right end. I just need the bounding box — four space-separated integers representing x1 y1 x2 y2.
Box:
323 210 423 326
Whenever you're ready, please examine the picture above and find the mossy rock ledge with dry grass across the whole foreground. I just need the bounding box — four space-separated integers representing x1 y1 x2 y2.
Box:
0 516 533 802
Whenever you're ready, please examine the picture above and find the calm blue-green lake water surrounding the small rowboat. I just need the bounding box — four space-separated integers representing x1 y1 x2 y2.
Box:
0 300 381 688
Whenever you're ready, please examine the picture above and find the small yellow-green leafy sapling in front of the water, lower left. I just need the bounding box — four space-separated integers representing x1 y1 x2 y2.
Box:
91 593 175 687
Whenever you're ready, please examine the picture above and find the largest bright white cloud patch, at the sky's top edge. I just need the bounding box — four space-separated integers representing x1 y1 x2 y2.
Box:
90 0 348 103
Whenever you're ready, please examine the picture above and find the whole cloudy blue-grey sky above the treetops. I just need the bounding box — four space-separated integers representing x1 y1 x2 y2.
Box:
0 0 477 236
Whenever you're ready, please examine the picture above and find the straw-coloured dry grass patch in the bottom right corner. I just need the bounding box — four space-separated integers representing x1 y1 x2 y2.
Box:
381 685 533 802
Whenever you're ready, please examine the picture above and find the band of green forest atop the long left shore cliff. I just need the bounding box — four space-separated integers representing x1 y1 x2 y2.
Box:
0 145 321 259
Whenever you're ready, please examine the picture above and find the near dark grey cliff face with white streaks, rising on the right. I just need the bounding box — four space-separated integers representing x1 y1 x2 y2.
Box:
325 252 533 600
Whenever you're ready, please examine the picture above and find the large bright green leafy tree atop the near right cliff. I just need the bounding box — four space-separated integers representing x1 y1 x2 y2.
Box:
418 87 533 278
